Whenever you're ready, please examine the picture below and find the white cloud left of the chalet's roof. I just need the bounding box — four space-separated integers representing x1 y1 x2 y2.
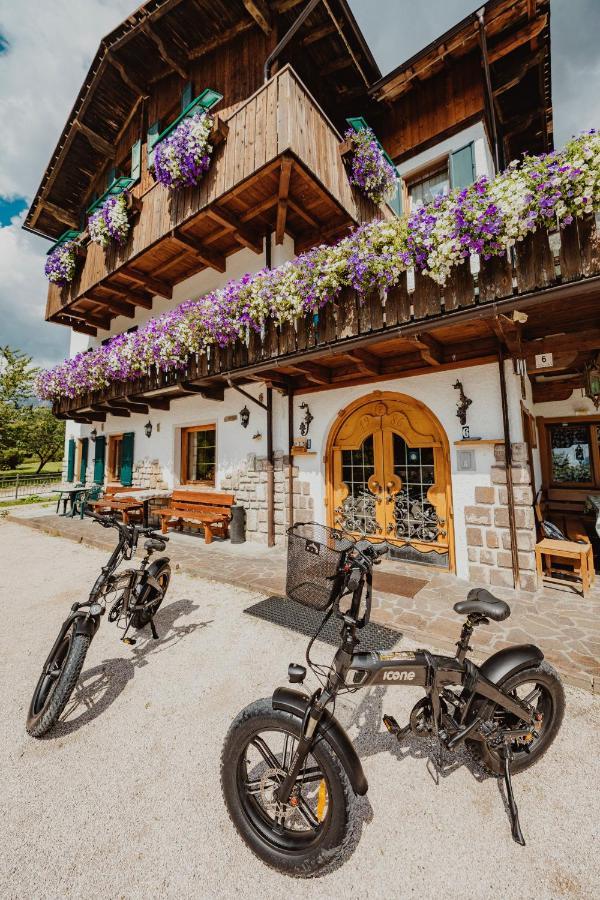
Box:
0 0 138 365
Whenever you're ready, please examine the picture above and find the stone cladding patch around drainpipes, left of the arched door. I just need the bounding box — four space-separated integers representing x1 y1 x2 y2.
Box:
221 451 314 544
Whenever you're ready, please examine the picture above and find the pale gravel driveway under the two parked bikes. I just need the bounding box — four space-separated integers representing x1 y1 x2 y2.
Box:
0 520 600 900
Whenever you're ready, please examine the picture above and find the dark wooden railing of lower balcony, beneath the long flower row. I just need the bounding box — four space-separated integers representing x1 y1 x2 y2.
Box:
54 216 600 419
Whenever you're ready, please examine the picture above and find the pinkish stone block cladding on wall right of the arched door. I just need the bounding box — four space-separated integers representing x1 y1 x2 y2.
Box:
465 444 537 591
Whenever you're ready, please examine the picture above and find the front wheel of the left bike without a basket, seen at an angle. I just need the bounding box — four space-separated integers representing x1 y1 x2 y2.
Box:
26 626 90 737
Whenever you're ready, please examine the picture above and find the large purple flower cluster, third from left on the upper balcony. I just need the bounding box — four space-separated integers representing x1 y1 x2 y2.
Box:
154 110 213 188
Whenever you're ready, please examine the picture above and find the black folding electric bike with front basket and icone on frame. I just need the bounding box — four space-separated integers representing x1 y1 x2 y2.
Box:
221 523 565 877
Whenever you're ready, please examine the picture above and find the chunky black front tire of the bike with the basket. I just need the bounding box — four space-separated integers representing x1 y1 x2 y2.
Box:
221 697 356 878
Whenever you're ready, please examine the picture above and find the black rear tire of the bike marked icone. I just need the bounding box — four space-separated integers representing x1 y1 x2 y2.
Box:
465 660 565 775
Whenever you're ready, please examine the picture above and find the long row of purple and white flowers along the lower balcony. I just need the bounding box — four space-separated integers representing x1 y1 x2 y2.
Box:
38 131 600 400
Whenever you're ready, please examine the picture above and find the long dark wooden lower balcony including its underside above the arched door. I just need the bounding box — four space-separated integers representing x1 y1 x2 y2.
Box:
54 216 600 422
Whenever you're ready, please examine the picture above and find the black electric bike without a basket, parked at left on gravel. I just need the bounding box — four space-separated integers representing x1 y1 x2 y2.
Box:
26 512 171 737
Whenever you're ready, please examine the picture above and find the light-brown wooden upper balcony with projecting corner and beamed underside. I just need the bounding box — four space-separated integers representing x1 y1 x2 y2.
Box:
46 66 389 334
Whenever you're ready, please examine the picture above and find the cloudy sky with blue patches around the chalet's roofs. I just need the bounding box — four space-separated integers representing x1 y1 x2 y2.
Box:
0 0 600 366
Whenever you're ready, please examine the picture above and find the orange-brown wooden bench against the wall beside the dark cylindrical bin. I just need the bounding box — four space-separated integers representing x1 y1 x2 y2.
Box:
156 491 235 544
